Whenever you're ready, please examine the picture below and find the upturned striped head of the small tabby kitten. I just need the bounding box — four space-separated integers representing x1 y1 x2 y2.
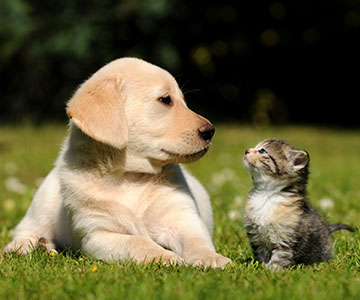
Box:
244 139 310 186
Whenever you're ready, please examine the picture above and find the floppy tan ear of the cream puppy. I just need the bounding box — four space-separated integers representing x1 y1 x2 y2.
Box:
66 76 129 149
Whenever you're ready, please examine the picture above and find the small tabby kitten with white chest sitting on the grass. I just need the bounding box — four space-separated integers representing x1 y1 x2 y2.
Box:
244 139 354 269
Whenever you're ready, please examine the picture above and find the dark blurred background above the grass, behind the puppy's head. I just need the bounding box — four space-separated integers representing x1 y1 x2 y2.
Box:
0 0 360 127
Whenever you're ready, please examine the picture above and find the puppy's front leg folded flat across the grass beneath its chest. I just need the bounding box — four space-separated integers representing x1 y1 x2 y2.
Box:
82 230 183 264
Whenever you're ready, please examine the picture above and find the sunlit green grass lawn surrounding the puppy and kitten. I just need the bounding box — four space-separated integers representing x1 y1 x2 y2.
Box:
0 125 360 300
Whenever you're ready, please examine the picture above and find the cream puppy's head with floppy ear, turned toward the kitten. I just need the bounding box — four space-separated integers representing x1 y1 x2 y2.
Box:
67 58 215 171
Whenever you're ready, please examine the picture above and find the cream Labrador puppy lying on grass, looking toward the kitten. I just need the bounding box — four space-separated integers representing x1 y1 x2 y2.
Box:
5 58 230 268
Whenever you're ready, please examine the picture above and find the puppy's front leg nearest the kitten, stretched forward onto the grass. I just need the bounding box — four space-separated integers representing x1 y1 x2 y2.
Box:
146 190 231 268
